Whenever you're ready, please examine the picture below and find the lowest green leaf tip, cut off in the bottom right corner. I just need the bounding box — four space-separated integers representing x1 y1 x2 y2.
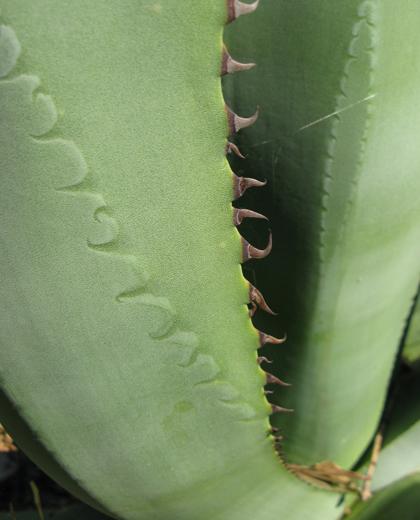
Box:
345 473 420 520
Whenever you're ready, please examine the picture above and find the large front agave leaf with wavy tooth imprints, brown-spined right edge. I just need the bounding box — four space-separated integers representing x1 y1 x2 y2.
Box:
0 4 348 520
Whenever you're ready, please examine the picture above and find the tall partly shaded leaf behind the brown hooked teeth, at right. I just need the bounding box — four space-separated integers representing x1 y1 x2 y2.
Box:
224 0 420 467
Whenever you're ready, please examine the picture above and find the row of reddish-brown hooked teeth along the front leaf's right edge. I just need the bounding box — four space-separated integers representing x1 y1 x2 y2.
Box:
222 0 293 428
